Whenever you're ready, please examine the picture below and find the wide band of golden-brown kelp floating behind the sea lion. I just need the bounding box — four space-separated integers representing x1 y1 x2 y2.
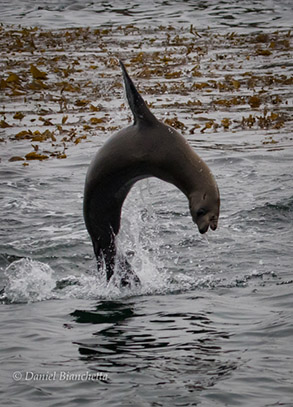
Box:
0 25 293 165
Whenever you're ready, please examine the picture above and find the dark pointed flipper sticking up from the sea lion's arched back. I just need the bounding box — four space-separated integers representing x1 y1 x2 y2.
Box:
119 60 157 124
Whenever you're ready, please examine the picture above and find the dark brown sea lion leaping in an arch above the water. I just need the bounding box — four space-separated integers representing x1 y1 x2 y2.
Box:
83 61 220 281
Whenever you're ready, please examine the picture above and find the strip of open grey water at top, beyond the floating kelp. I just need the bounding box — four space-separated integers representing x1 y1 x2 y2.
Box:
1 0 292 32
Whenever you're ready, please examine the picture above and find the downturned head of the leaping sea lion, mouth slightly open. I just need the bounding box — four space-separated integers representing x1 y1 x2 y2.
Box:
189 185 220 234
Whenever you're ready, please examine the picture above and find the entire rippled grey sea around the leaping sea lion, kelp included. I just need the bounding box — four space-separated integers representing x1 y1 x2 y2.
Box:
0 0 293 407
